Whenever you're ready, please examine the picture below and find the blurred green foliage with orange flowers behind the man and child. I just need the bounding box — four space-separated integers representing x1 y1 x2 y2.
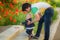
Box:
0 0 60 26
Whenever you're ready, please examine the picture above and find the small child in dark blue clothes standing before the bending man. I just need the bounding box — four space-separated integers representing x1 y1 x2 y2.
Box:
22 14 34 38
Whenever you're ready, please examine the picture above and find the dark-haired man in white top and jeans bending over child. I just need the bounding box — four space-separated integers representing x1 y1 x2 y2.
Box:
22 2 54 40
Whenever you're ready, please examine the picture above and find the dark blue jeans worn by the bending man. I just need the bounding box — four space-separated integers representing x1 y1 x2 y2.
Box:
35 8 54 40
